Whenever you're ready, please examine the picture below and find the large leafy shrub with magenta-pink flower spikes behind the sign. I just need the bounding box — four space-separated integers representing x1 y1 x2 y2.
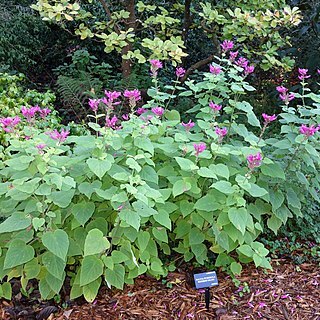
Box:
0 45 320 301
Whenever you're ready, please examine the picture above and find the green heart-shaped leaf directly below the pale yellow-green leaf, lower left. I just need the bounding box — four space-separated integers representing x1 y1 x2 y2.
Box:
80 256 104 286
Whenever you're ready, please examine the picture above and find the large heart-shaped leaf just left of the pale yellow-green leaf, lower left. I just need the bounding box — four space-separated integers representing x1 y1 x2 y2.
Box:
42 229 69 261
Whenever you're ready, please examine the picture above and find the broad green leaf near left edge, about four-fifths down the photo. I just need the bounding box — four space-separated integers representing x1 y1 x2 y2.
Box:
4 239 34 269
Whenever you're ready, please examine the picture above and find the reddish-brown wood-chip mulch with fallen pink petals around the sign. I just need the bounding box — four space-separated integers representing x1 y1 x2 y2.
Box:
0 260 320 320
